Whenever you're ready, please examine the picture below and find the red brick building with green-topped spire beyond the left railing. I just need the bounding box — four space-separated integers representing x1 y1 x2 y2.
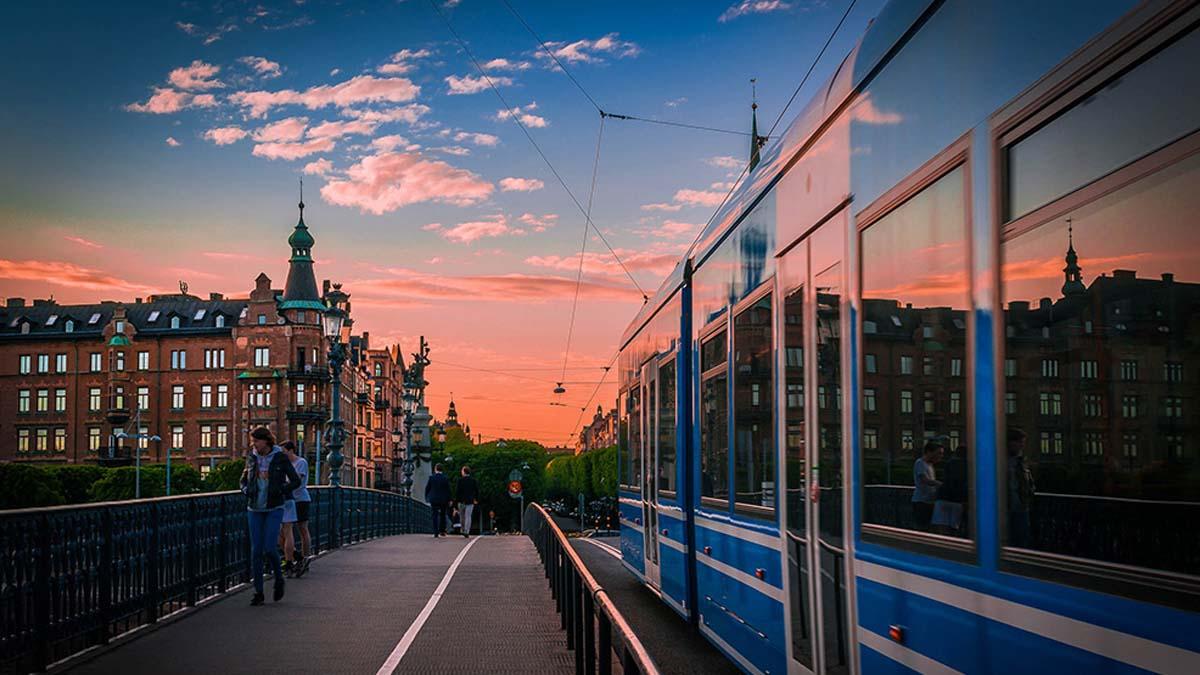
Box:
0 203 403 485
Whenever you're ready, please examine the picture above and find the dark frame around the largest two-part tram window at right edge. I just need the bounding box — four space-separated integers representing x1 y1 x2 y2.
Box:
991 5 1200 609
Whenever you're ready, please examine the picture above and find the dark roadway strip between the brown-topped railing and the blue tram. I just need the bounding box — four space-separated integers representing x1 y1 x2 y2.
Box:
571 537 742 675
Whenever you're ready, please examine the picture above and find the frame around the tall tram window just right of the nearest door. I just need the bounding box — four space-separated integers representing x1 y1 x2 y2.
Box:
852 132 980 565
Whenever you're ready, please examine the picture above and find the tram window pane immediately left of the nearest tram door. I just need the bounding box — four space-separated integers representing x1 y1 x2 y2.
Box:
733 294 775 509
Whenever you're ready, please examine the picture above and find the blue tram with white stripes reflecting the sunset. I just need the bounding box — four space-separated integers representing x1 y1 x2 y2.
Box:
618 0 1200 674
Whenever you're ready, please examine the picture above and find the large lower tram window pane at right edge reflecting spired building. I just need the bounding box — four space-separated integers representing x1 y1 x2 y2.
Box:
1001 148 1200 578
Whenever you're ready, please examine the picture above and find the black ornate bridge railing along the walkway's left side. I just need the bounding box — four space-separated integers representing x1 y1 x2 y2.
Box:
0 486 431 673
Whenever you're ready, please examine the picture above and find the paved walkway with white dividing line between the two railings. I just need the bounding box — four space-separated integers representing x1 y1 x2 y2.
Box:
63 534 575 675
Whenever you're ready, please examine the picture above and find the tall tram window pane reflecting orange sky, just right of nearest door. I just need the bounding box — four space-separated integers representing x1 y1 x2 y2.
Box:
862 166 972 538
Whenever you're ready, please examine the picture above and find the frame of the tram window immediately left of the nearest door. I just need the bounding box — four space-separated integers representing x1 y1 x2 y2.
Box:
726 281 779 519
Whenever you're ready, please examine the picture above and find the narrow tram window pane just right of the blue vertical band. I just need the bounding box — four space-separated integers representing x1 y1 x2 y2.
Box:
700 330 730 501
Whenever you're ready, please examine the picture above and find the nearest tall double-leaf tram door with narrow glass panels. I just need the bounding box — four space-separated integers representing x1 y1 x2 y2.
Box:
776 214 853 675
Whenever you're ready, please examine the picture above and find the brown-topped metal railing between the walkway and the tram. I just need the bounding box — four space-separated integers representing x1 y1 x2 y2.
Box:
523 503 659 675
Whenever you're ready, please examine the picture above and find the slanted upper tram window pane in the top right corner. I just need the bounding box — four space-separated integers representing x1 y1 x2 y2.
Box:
1007 24 1200 219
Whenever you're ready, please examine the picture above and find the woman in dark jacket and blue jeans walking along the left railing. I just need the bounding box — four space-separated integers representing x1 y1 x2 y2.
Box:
241 426 300 607
